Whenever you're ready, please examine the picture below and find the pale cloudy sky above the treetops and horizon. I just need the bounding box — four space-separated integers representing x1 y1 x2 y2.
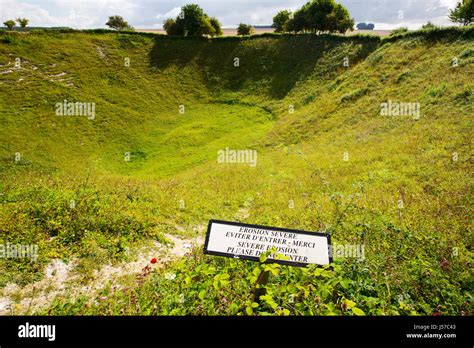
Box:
0 0 459 30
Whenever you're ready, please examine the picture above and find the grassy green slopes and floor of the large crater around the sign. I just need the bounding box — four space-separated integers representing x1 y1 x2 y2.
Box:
0 27 474 315
